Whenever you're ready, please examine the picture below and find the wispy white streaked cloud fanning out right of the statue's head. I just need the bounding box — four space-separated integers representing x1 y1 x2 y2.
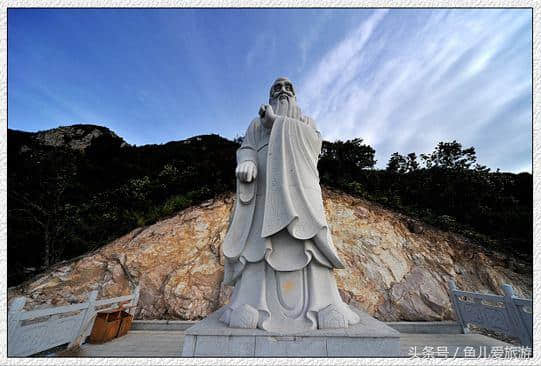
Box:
299 10 532 171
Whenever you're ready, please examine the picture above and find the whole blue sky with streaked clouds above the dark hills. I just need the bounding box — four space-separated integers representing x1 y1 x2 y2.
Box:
8 9 532 172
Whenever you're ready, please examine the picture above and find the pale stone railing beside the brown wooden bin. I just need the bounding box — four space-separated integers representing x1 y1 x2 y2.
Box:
8 287 139 357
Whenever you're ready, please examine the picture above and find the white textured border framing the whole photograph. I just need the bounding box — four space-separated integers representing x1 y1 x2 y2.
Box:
0 0 541 366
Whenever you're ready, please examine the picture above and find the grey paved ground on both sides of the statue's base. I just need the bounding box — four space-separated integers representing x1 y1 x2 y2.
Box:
56 330 510 358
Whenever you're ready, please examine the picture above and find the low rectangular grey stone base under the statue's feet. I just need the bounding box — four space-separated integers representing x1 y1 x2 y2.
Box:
182 307 400 357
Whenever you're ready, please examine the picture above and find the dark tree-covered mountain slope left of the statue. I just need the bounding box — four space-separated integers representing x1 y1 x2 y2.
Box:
7 125 238 285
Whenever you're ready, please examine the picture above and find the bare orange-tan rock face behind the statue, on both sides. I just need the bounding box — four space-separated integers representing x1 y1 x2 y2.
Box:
8 190 532 321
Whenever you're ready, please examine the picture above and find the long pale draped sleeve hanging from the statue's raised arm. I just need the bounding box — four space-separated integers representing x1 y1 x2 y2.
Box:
262 116 344 268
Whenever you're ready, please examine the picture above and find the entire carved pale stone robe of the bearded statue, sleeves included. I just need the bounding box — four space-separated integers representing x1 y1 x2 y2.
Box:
220 115 359 331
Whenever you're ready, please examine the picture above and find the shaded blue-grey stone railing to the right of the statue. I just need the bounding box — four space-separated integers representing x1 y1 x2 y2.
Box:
449 280 533 347
